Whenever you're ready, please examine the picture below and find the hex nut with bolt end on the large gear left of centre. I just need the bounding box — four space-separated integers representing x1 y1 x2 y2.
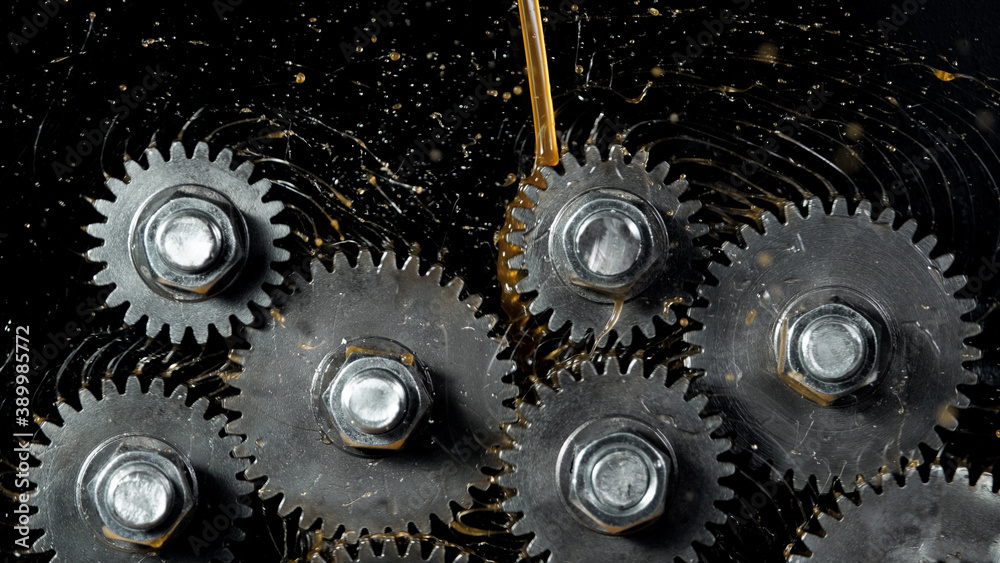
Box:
322 352 433 452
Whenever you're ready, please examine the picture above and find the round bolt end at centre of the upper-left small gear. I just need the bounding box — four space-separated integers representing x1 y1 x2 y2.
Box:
155 210 223 273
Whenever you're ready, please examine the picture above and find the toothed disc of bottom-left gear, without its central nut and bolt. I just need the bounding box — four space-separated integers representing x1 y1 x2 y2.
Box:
30 377 253 563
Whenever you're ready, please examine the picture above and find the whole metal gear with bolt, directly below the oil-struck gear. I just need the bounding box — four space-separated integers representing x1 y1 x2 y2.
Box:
498 358 734 563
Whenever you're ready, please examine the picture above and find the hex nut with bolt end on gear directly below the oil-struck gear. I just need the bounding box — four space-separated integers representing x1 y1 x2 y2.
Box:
568 431 670 535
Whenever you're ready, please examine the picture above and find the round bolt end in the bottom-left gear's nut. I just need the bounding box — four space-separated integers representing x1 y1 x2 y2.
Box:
107 462 174 530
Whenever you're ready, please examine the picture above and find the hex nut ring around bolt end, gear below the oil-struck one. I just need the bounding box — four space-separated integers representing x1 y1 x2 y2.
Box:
569 432 670 535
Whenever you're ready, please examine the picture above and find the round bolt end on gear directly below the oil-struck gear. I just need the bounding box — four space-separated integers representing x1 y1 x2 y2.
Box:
591 449 650 510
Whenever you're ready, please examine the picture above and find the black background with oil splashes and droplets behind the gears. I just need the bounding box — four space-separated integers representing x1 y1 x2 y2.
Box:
0 0 1000 561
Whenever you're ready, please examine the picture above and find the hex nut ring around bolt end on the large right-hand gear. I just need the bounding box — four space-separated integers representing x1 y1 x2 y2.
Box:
776 303 878 406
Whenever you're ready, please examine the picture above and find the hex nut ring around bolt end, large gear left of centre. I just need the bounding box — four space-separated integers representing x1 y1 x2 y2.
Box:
322 352 433 451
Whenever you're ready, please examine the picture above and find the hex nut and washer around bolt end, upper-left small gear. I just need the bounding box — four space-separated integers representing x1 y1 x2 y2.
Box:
133 186 249 300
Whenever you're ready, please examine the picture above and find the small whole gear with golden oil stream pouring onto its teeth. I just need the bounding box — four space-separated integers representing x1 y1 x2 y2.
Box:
508 145 708 345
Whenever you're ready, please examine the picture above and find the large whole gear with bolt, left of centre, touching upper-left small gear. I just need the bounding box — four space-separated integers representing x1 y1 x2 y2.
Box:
225 251 516 540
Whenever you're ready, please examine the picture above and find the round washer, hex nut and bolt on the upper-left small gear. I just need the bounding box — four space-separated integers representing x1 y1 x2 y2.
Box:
130 186 248 301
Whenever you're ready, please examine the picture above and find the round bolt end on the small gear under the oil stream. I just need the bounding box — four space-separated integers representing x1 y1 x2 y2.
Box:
575 209 642 276
